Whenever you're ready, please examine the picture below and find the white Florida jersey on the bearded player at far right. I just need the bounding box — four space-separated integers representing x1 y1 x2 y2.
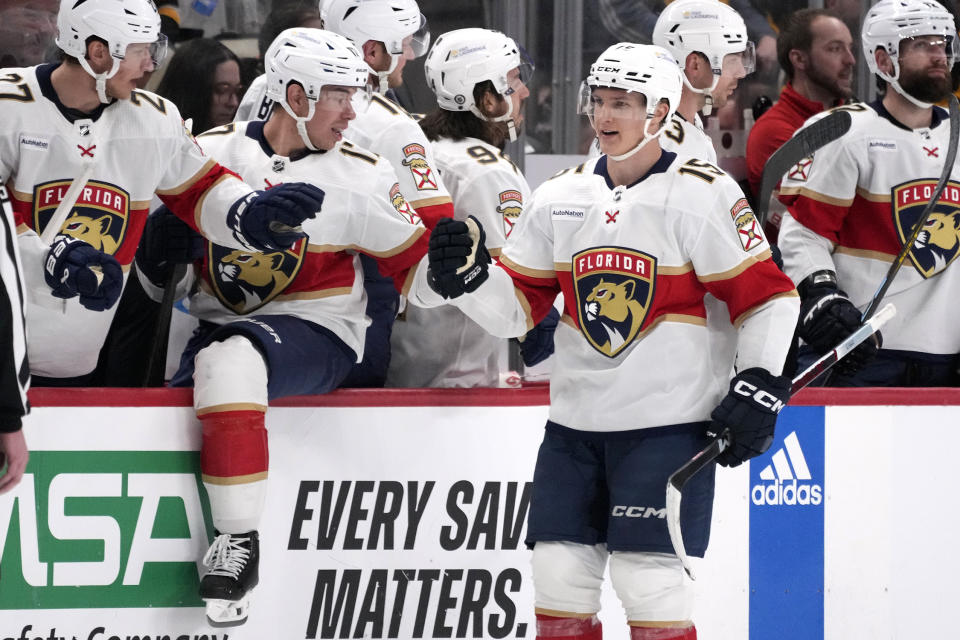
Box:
780 102 960 354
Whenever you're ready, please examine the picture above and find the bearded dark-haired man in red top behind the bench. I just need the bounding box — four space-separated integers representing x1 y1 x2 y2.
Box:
747 9 856 242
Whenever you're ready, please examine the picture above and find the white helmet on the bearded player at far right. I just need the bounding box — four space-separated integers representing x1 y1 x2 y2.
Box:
860 0 957 108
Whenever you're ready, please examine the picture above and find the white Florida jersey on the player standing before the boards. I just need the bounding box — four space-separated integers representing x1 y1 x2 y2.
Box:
440 152 799 431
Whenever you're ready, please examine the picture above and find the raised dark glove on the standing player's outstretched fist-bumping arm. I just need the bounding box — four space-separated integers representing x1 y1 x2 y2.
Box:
427 216 490 298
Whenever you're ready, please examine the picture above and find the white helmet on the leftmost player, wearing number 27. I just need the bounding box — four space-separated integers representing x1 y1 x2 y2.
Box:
56 0 167 103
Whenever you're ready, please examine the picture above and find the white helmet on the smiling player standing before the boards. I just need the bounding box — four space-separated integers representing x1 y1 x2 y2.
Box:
577 42 683 160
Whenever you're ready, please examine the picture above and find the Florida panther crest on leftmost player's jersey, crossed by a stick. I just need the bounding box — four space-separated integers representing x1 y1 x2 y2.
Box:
33 180 130 255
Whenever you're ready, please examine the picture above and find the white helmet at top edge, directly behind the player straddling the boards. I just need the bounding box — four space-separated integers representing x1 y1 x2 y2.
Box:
320 0 430 92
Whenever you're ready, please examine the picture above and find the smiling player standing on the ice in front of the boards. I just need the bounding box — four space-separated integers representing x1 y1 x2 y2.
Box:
429 43 799 640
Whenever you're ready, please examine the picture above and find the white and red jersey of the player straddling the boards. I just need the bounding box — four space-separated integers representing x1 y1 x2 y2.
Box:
188 121 428 359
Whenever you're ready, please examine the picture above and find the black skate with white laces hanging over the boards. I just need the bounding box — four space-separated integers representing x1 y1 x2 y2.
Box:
200 531 260 627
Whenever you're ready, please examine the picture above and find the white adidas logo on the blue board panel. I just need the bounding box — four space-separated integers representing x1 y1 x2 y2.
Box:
750 431 823 506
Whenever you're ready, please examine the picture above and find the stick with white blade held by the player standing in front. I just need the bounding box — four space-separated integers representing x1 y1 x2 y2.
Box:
667 304 897 580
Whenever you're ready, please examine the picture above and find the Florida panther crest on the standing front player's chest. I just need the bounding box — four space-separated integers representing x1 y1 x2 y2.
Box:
572 247 657 358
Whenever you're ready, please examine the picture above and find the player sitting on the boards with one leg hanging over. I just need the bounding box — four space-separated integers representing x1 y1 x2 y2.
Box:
137 28 440 625
